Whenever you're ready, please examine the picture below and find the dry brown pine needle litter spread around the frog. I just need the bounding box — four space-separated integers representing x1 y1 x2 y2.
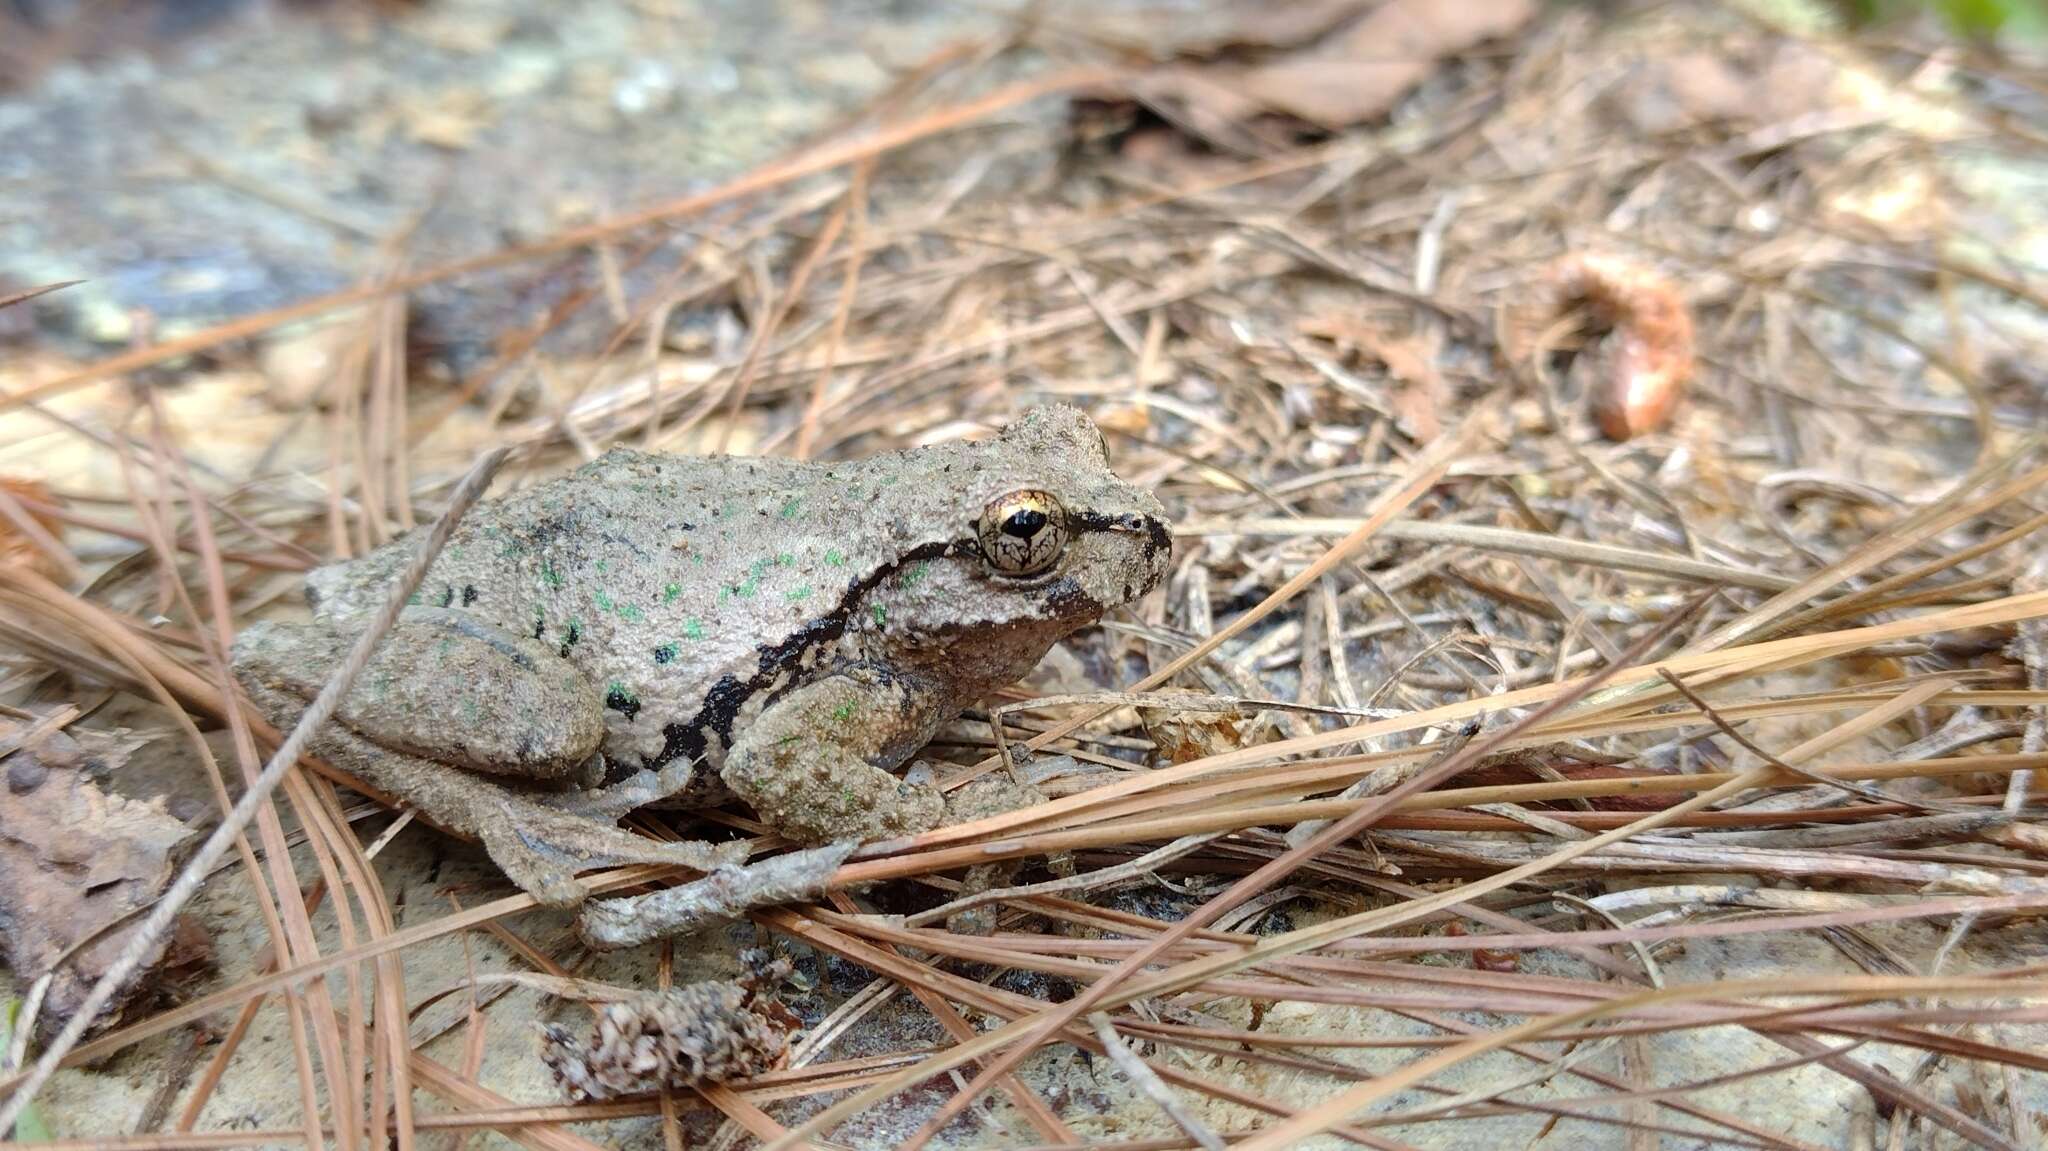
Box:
0 0 2048 1151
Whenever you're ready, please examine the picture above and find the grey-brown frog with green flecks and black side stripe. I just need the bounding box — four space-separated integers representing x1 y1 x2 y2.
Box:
231 406 1174 905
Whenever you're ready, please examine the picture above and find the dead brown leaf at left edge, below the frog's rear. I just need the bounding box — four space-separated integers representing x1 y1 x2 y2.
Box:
0 731 193 1032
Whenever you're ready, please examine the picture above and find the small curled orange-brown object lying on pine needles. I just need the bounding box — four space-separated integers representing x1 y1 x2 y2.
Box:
1550 256 1694 440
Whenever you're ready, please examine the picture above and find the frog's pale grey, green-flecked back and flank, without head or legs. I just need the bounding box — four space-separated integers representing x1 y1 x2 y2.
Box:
307 449 925 762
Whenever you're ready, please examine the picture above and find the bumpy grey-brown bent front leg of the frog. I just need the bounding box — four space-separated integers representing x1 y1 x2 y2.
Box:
721 664 946 844
